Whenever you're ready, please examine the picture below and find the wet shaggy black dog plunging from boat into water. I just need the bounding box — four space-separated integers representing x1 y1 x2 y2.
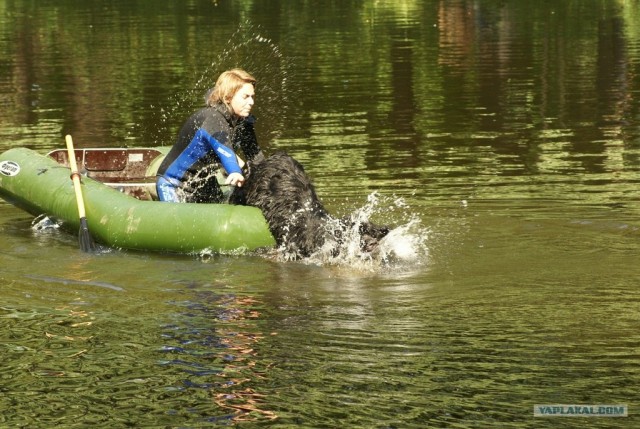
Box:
230 152 389 258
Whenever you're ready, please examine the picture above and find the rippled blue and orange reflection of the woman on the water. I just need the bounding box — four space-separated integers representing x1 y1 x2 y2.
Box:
160 287 277 422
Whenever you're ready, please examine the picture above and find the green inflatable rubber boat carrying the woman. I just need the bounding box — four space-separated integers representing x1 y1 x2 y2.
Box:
0 148 275 253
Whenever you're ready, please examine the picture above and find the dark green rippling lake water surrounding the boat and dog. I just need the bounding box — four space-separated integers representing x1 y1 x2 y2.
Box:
0 0 640 428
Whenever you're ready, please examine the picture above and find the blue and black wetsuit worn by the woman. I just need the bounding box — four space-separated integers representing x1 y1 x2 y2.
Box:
156 104 263 203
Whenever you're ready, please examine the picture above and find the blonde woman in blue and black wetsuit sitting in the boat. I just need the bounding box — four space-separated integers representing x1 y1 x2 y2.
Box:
156 69 264 203
